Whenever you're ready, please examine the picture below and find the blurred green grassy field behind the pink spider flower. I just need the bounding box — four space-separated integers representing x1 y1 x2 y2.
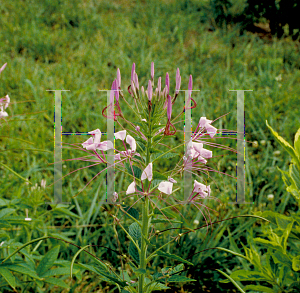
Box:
0 0 300 292
